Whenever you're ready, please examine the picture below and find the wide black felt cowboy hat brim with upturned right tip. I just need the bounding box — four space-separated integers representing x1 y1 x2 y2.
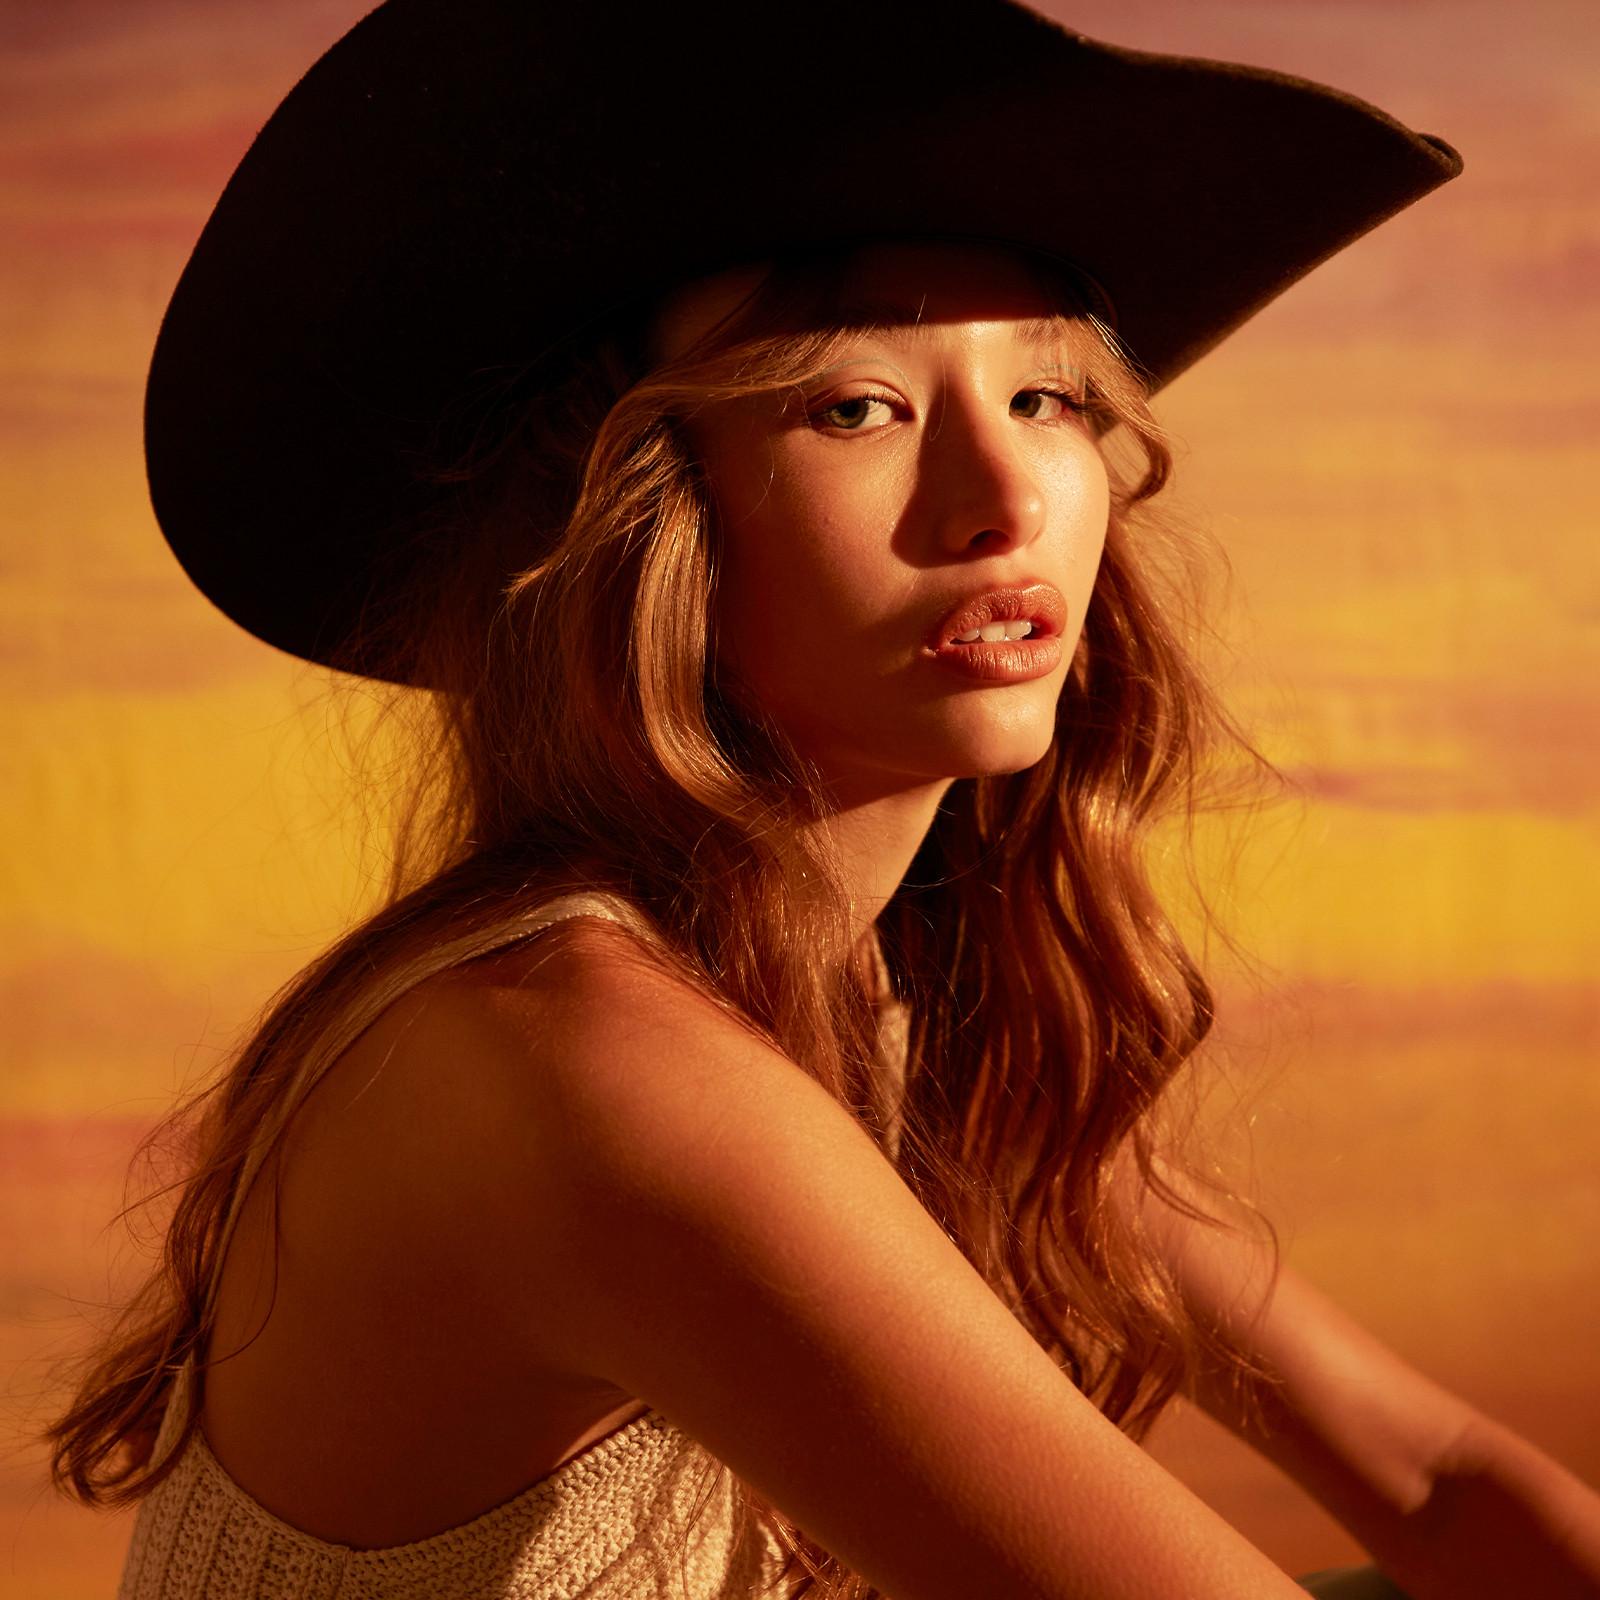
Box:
146 0 1461 680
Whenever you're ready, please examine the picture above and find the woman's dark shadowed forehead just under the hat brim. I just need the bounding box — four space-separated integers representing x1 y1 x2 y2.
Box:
651 242 1064 358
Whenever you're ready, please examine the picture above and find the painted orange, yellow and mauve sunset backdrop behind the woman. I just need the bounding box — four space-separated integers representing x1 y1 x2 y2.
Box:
0 0 1600 1600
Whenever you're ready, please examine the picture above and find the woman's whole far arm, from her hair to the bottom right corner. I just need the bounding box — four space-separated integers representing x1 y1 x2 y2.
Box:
1126 1177 1600 1600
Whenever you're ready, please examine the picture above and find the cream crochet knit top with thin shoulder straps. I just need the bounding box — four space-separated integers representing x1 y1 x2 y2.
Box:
117 894 906 1600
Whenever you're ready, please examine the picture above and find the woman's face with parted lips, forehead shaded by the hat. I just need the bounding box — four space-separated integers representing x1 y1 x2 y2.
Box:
656 245 1109 802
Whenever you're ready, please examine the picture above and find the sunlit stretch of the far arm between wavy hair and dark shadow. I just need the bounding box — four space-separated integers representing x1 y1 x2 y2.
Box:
1146 1173 1477 1549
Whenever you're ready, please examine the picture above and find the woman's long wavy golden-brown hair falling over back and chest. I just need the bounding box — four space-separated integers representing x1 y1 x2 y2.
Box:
45 240 1272 1600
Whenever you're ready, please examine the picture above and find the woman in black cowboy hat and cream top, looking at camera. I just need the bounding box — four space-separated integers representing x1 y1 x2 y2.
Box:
40 0 1600 1600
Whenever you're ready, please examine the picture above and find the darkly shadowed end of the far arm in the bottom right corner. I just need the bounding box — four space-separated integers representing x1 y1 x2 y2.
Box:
1371 1414 1600 1600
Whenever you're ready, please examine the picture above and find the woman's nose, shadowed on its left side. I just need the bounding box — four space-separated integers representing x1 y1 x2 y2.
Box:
922 395 1045 555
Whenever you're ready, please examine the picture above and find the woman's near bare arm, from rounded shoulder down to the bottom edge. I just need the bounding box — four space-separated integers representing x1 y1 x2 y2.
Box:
419 941 1298 1600
